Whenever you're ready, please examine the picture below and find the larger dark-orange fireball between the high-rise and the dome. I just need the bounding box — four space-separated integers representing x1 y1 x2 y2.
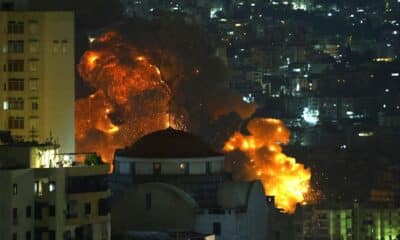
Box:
75 32 178 165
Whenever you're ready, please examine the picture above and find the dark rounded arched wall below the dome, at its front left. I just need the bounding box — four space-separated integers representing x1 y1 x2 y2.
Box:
111 183 197 234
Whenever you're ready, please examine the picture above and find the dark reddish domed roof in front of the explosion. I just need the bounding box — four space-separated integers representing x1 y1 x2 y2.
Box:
116 128 221 158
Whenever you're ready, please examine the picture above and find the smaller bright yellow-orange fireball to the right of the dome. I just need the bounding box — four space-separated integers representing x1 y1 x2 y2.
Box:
224 118 311 213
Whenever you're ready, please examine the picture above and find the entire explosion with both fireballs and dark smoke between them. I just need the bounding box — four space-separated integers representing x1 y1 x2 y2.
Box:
75 21 311 210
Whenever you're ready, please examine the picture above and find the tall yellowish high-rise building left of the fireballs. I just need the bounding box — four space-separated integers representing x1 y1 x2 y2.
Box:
0 11 75 152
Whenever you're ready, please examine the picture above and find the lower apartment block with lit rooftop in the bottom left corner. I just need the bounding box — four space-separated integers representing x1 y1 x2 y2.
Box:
0 140 111 240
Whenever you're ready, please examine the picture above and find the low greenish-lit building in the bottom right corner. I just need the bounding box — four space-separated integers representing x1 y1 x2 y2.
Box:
295 204 400 240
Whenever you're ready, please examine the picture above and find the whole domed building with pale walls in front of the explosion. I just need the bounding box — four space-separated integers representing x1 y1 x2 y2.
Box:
110 128 267 240
